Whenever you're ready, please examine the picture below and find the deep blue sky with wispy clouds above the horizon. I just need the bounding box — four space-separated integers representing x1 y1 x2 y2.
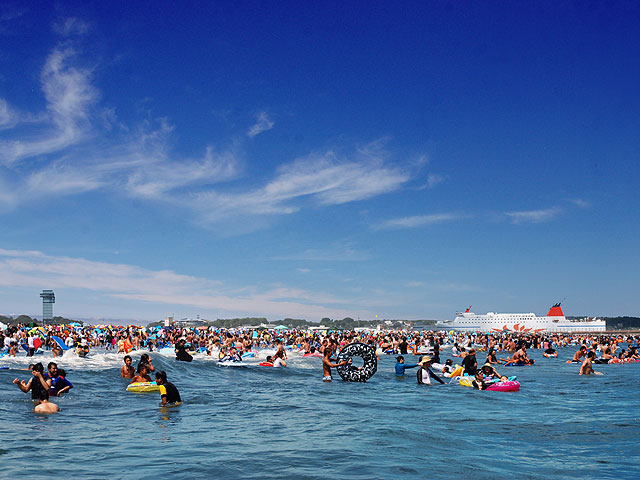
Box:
0 1 640 321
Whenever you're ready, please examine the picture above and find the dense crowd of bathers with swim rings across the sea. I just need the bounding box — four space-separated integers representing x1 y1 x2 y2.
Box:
0 325 640 412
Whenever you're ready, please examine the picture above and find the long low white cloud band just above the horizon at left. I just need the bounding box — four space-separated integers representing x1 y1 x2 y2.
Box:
0 249 370 319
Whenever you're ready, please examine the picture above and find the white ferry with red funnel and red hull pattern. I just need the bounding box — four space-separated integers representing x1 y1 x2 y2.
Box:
436 303 607 333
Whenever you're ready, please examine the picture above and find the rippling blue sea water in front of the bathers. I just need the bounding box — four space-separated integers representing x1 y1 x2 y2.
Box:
0 347 640 479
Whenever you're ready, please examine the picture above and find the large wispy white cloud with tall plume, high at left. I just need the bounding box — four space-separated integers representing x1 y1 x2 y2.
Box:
0 32 415 230
